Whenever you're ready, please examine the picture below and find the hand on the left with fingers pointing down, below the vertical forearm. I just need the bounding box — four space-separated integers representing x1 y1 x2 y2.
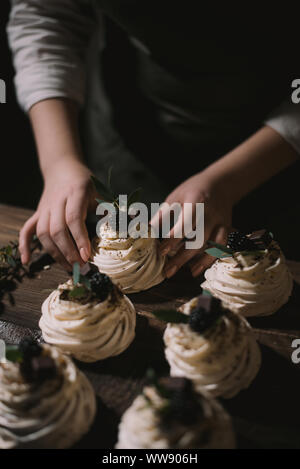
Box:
19 160 96 271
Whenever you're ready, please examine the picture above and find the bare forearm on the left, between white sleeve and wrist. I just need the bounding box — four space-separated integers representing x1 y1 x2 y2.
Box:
29 99 86 179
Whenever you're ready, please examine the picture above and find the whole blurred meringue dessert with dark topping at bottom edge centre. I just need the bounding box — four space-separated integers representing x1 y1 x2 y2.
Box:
116 378 235 449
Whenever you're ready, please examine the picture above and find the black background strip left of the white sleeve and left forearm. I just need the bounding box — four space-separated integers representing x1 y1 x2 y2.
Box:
0 0 42 208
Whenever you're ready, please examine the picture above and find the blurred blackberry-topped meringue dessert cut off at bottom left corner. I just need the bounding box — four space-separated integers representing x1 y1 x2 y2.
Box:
0 339 96 449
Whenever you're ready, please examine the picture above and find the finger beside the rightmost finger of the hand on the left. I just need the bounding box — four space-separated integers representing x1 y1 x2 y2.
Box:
50 202 82 265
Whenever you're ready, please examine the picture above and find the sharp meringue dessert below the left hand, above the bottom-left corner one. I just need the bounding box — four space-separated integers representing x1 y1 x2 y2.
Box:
39 271 136 362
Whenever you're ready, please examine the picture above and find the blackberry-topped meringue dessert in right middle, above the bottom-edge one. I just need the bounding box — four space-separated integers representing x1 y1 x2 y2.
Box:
157 295 261 399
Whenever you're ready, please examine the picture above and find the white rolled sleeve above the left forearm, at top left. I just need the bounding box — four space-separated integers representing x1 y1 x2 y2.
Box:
7 0 95 111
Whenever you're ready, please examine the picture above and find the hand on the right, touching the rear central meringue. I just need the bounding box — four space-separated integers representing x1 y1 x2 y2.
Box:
151 171 233 278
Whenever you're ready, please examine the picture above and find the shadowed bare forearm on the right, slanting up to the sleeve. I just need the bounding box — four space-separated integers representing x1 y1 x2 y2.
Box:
204 127 299 204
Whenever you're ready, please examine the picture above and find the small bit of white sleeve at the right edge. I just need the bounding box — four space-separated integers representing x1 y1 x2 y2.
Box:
264 98 300 154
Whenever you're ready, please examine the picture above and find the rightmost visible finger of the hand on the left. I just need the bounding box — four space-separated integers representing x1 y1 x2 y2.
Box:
65 192 91 262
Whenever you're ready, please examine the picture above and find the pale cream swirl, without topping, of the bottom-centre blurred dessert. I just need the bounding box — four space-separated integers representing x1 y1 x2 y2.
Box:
116 387 235 449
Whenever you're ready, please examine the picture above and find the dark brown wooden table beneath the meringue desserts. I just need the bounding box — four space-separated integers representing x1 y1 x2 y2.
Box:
0 205 300 448
